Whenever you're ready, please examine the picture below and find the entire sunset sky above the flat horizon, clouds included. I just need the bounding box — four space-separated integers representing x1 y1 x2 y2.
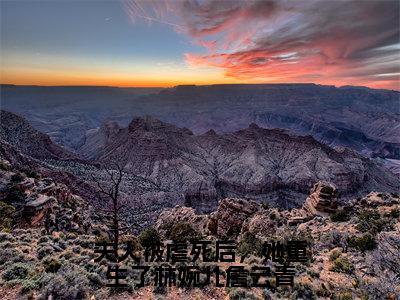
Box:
0 0 400 90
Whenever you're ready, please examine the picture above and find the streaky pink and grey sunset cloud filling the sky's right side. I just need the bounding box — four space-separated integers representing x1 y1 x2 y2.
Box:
123 0 400 89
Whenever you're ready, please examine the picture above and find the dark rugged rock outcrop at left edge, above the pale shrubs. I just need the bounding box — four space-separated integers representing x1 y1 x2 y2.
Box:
0 160 93 233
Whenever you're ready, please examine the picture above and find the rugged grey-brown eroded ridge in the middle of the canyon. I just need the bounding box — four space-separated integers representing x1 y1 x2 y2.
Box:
82 113 400 210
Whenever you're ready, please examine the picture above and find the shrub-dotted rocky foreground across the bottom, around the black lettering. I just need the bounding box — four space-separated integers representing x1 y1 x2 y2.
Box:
0 160 400 299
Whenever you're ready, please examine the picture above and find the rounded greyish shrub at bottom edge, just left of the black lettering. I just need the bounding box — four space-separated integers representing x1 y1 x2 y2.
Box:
41 264 89 300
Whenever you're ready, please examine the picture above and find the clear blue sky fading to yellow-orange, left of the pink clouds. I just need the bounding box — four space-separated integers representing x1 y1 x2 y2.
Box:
1 1 222 85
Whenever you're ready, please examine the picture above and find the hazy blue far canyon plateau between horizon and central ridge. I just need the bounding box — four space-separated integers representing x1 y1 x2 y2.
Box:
1 83 400 159
